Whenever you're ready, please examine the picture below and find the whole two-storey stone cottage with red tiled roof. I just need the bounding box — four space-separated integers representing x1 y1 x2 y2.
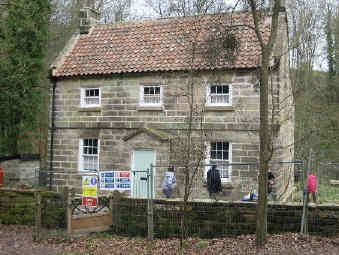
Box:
48 2 294 199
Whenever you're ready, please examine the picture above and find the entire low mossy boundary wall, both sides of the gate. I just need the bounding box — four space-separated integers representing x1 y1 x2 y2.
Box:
0 188 339 238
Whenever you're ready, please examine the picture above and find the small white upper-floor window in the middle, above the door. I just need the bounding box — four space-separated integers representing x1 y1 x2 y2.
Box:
140 85 162 106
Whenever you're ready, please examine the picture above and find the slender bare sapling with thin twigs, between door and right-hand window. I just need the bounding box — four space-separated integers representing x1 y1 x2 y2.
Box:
165 11 239 251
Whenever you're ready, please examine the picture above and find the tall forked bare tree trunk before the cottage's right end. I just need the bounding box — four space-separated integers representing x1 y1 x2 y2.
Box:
243 0 281 247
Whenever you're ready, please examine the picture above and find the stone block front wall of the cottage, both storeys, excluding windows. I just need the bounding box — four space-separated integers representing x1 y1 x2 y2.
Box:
47 63 294 200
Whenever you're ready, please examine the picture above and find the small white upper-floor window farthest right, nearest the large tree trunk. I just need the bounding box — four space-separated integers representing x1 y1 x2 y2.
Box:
206 84 232 106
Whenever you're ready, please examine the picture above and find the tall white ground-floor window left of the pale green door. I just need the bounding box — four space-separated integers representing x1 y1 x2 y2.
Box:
79 138 100 171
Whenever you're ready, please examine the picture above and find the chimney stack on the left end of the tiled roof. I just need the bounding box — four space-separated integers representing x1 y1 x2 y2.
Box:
79 0 100 34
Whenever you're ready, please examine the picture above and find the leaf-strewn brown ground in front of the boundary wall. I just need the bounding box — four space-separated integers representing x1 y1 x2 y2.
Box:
0 225 339 255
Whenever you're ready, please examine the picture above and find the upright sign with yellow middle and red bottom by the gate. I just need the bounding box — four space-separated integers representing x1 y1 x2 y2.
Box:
82 175 98 206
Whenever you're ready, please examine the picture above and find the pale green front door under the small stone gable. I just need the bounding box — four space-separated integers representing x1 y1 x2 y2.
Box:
132 150 155 198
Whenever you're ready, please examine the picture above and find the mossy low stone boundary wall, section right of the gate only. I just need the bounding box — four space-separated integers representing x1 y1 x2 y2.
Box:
112 198 339 238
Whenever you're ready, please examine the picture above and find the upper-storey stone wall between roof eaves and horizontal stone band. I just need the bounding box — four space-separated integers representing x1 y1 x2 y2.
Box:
50 72 259 130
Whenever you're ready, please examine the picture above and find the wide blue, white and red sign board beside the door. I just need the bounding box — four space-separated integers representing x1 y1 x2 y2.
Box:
100 171 131 191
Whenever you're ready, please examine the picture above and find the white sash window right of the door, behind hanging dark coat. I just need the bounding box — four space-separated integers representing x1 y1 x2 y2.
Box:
205 141 232 182
